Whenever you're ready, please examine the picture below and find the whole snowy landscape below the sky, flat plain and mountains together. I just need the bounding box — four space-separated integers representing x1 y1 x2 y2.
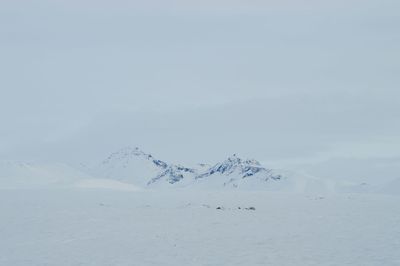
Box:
0 151 400 266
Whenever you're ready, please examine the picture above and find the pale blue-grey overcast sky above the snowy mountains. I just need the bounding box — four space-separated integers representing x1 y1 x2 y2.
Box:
0 0 400 181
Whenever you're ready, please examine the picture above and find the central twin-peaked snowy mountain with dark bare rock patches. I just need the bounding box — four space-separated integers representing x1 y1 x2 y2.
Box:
92 147 284 188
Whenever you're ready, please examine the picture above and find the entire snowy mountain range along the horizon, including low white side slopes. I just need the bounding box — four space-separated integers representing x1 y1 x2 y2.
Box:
0 148 394 194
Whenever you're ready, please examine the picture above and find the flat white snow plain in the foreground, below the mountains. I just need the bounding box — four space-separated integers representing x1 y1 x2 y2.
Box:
0 188 400 266
